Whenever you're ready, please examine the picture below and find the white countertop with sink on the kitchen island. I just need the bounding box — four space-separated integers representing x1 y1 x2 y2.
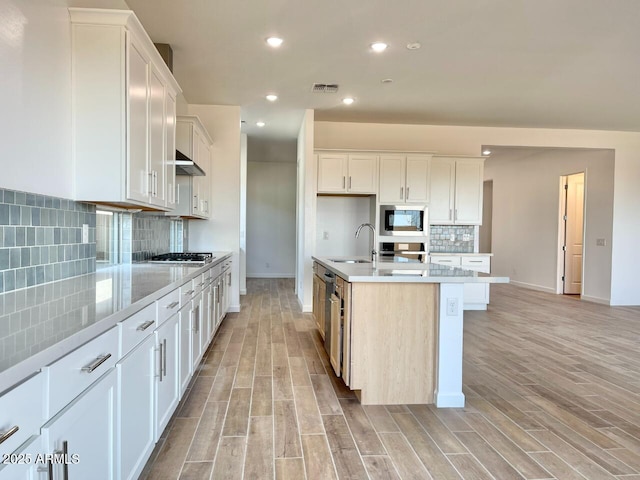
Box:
311 257 509 283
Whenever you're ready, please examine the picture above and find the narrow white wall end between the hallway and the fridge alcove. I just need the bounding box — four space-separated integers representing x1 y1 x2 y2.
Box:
296 110 317 312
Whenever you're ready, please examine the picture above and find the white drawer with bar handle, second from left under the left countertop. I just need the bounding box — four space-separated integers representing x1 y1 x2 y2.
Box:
43 327 118 418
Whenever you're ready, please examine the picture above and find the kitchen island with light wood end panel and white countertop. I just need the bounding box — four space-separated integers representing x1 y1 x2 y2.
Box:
313 257 509 407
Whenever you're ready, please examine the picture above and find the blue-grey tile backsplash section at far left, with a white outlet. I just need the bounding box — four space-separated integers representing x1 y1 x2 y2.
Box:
0 189 96 293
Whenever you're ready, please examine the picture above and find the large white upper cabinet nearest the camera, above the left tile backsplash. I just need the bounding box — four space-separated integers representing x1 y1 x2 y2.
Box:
69 8 181 210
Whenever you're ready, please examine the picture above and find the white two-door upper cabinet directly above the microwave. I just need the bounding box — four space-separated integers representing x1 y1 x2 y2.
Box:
379 155 431 204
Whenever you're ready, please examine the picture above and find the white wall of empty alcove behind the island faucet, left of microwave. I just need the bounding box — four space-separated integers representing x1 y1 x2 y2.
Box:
316 196 378 257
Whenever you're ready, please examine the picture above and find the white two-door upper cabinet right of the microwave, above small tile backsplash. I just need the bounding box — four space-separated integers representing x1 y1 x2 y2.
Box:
429 157 484 225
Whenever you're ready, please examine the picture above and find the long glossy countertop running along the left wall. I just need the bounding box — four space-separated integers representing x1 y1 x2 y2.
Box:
0 252 231 393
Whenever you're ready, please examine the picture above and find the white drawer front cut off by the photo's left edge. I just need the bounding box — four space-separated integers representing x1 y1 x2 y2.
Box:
0 373 45 459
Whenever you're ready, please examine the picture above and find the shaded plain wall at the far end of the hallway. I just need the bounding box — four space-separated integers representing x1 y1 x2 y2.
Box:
247 161 297 278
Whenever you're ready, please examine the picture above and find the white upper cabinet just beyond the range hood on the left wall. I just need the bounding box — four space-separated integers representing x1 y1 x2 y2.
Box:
170 115 213 218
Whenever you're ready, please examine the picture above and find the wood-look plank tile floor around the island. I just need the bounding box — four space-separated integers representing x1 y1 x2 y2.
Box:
142 280 640 480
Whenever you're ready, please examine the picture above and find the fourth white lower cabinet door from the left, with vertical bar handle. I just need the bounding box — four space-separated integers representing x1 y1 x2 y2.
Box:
154 315 180 442
